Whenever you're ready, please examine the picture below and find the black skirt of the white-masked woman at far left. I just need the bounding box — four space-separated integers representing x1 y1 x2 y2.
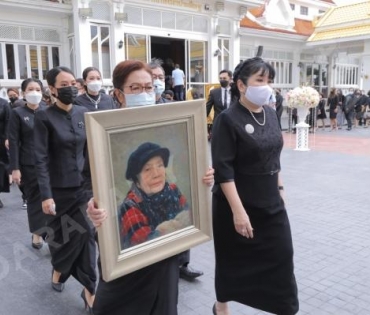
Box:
20 165 47 235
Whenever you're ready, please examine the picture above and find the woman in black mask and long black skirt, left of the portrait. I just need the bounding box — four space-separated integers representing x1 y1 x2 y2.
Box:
34 67 96 312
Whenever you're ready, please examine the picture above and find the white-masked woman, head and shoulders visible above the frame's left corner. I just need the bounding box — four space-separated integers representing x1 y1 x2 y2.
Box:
75 67 116 112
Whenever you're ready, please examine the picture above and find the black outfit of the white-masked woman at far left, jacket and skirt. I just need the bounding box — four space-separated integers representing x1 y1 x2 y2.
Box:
9 105 46 235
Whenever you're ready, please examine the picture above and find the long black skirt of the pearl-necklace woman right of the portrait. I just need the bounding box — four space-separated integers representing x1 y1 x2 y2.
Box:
213 174 298 315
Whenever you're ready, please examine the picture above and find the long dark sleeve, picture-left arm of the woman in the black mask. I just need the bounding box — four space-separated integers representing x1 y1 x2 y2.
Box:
34 111 53 201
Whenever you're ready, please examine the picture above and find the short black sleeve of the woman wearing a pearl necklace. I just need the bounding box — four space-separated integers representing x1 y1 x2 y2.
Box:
211 112 237 184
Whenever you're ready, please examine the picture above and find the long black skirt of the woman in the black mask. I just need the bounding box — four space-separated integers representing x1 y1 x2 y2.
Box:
47 187 96 294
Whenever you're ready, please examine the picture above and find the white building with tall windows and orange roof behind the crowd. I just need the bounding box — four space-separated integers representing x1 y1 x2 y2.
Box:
0 0 370 97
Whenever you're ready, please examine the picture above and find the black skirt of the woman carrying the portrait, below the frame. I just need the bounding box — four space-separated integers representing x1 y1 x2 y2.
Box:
93 256 179 315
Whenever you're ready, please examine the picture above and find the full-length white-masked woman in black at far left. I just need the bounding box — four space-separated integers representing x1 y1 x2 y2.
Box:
9 78 46 249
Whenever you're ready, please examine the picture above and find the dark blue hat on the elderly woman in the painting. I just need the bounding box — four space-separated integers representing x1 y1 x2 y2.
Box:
126 142 170 180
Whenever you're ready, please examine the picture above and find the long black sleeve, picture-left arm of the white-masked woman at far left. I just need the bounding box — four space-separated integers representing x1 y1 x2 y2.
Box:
8 110 21 171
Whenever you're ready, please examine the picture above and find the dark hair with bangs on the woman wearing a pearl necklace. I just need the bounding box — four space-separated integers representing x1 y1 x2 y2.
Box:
231 57 275 98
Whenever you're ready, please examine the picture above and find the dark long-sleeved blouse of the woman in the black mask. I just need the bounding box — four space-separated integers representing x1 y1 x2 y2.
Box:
34 105 87 200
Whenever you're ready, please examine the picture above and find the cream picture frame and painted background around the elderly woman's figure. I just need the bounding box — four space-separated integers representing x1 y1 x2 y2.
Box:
85 100 212 281
